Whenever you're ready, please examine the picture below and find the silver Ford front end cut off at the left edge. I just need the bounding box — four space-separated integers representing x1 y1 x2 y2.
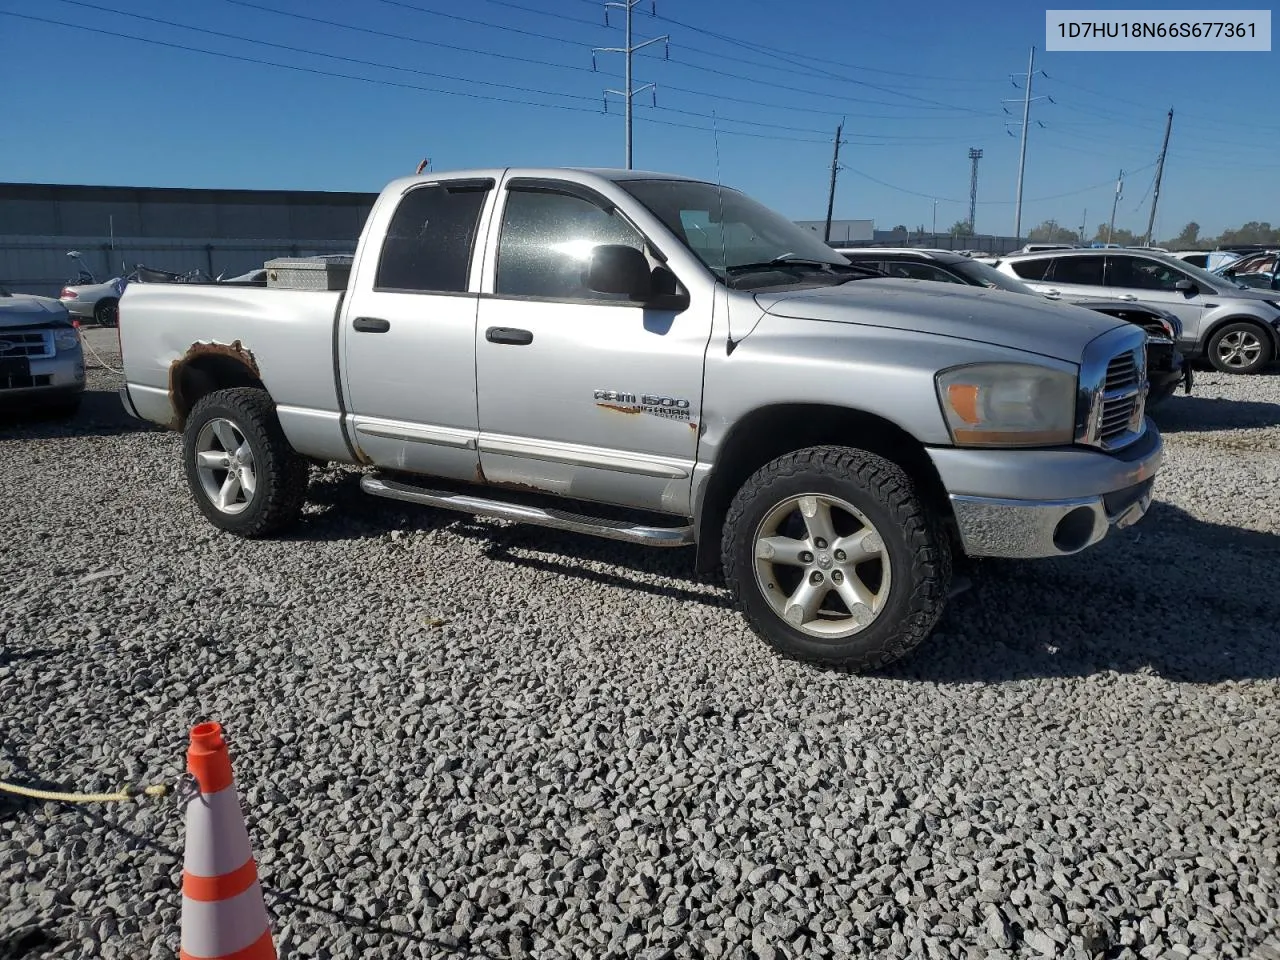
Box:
0 288 84 416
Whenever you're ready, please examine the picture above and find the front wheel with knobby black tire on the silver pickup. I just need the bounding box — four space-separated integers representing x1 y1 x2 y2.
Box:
721 447 951 671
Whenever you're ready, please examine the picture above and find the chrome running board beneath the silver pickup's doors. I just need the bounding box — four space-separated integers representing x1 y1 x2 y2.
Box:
360 474 694 547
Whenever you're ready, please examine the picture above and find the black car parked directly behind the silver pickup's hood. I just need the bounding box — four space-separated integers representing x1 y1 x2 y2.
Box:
836 247 1194 408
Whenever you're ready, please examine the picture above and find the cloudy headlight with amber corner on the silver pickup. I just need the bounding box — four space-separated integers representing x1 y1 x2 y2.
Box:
937 364 1076 447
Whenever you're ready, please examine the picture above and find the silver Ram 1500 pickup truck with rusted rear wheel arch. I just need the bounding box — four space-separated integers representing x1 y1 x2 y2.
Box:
120 169 1162 669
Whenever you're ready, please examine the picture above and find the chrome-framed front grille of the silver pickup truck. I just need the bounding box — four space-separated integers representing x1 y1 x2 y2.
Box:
1076 326 1147 451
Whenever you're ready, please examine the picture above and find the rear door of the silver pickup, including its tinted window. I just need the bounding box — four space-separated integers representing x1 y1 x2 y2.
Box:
340 179 494 480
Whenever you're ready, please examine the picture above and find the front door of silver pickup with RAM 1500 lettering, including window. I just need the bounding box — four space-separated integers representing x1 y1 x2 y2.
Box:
476 178 712 515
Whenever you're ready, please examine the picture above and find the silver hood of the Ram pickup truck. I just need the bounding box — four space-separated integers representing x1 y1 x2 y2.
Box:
755 279 1126 364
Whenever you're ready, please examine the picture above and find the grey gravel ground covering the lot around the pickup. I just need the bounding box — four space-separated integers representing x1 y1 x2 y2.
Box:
0 332 1280 960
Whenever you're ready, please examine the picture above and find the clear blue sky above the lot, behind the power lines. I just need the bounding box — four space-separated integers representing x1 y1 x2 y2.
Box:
0 0 1280 237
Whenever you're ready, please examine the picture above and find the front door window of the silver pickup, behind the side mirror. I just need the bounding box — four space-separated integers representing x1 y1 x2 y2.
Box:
494 188 644 301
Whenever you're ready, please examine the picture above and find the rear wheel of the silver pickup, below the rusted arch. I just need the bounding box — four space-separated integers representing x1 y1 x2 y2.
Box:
183 387 308 538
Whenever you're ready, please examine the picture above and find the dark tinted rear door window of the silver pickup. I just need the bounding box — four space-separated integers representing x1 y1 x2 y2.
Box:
374 183 488 293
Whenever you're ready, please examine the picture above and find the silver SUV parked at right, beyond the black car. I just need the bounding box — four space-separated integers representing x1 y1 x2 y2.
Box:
996 250 1280 374
